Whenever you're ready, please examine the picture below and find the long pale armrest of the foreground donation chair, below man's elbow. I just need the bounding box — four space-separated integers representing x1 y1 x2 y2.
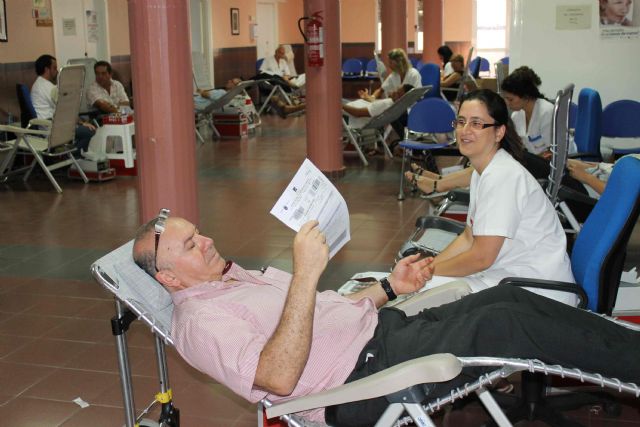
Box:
267 353 462 418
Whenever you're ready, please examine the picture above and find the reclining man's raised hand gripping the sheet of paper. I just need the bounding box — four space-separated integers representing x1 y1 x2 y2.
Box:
293 220 329 278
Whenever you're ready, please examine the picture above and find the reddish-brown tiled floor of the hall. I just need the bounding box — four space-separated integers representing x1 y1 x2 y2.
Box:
0 117 640 427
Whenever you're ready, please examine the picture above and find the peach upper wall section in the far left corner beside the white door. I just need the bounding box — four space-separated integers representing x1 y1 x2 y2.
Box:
0 0 55 63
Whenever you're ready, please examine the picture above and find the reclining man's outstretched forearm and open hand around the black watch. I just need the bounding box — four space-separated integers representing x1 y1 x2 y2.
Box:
347 254 433 307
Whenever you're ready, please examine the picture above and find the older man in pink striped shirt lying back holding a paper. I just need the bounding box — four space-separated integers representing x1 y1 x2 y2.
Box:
133 217 640 426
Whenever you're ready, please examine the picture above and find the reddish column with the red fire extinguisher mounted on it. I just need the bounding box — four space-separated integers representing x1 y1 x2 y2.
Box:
303 0 344 177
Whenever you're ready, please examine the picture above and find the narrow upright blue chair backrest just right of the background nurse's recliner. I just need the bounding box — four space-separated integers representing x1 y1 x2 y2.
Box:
575 88 602 157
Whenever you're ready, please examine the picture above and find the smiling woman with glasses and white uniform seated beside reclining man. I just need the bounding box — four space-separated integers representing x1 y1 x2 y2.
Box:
422 90 576 305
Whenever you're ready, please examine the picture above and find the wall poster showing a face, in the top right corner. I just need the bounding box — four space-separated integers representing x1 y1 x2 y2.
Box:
597 0 640 39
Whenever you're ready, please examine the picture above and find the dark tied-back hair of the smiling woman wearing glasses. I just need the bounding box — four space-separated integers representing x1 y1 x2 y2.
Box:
458 89 524 163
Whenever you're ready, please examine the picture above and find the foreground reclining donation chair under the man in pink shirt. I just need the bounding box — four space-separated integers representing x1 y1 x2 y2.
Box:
91 234 640 427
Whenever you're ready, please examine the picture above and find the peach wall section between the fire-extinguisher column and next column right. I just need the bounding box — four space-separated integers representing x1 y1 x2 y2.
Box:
340 0 376 43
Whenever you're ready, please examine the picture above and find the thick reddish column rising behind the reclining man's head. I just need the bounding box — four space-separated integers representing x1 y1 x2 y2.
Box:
129 0 199 224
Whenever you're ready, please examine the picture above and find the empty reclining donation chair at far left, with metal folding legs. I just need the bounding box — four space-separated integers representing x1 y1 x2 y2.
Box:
0 65 89 193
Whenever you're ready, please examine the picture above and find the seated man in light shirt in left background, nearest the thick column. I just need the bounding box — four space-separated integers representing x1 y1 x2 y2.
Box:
87 61 129 114
